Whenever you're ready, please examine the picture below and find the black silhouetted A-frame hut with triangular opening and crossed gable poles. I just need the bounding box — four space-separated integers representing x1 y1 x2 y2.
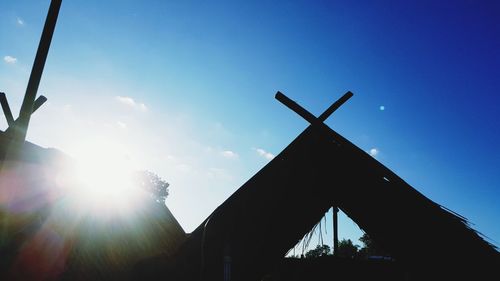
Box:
141 93 500 280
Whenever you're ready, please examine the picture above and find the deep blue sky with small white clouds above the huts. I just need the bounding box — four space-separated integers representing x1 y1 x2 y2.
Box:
0 0 500 249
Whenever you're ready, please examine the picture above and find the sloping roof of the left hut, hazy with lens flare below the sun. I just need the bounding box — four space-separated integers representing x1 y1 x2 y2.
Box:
0 132 186 280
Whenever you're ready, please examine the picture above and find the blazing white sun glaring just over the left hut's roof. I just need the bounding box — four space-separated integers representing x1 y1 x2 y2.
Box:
63 139 143 214
